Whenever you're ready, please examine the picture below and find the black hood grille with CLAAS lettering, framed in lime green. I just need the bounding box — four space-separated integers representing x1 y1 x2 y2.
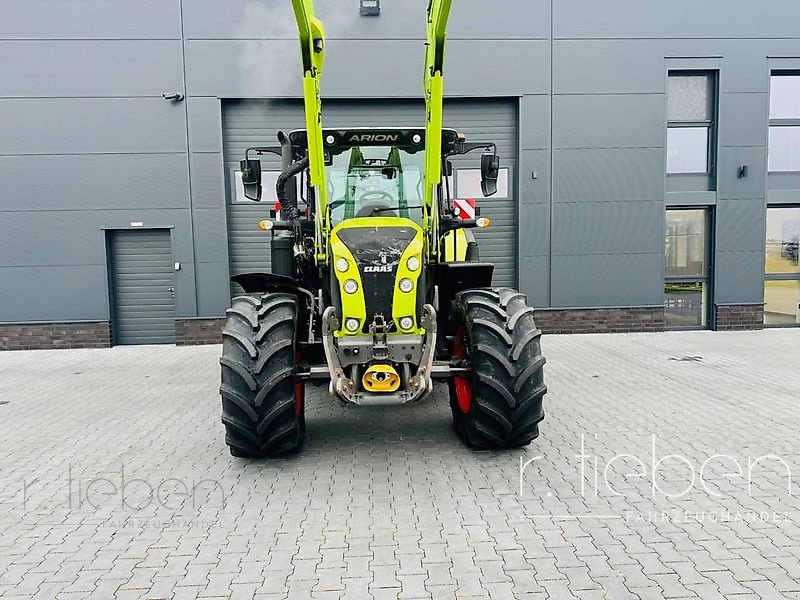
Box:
338 227 416 332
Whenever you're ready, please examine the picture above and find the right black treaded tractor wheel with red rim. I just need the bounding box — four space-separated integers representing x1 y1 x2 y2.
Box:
448 288 547 449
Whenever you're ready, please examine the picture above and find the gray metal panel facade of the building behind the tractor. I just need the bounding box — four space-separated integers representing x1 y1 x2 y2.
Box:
0 0 800 322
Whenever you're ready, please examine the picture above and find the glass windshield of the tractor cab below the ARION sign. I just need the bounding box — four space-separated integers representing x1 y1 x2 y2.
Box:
326 146 425 225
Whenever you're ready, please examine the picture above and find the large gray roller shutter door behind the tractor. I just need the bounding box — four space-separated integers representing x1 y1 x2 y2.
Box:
223 99 519 287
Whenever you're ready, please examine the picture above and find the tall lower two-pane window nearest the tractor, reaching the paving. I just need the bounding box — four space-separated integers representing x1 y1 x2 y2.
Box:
664 209 709 329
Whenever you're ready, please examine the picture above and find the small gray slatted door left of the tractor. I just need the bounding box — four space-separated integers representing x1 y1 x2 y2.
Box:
109 229 175 344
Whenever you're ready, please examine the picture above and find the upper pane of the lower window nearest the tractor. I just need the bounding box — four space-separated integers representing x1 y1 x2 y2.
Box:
664 210 707 277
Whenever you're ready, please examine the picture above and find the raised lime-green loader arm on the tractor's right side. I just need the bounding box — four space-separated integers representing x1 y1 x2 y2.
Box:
423 0 452 255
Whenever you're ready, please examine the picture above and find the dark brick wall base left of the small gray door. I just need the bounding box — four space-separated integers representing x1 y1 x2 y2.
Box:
0 321 111 350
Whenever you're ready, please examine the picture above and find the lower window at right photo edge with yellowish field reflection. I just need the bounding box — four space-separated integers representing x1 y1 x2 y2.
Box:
764 206 800 326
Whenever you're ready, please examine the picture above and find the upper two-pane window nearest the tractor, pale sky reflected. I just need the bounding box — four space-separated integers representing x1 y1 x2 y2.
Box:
667 71 717 175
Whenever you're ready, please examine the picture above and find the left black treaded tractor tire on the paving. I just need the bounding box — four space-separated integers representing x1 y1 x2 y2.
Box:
220 293 305 458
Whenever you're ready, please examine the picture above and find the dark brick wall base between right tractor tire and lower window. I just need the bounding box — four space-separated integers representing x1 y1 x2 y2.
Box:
535 306 664 333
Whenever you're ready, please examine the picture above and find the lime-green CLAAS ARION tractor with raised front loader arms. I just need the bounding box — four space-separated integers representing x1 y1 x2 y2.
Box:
220 0 546 458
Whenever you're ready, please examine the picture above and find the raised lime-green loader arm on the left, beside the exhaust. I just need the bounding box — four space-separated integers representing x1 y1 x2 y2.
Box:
292 0 329 263
